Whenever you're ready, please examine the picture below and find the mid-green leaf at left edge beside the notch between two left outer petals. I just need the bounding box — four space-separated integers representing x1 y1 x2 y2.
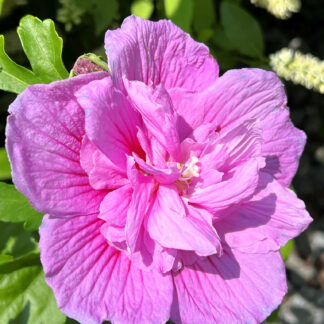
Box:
0 182 42 230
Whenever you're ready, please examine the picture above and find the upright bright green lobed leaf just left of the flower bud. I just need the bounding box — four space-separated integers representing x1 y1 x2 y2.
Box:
17 15 69 83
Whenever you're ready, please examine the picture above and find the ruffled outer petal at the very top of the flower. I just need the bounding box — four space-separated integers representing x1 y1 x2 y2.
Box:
105 16 218 90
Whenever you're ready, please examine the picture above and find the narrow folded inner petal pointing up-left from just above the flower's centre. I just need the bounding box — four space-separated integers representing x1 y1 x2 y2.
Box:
125 80 180 161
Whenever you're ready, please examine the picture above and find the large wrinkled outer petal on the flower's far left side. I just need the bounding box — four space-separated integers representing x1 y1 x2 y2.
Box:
6 72 107 216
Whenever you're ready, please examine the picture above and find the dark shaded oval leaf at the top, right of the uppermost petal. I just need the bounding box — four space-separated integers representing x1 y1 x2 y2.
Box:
220 1 264 57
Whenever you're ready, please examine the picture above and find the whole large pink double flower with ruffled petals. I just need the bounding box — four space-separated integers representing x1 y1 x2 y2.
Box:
7 16 311 324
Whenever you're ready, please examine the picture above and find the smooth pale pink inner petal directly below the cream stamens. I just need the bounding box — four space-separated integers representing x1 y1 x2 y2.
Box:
147 185 221 256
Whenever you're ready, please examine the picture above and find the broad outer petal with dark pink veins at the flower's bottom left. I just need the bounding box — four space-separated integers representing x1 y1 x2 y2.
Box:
40 215 173 324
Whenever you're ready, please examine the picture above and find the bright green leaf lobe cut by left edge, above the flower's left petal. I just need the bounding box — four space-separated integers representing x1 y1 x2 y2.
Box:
0 35 40 93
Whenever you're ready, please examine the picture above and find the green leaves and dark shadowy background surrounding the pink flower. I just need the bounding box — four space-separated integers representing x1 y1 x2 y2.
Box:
0 0 324 324
